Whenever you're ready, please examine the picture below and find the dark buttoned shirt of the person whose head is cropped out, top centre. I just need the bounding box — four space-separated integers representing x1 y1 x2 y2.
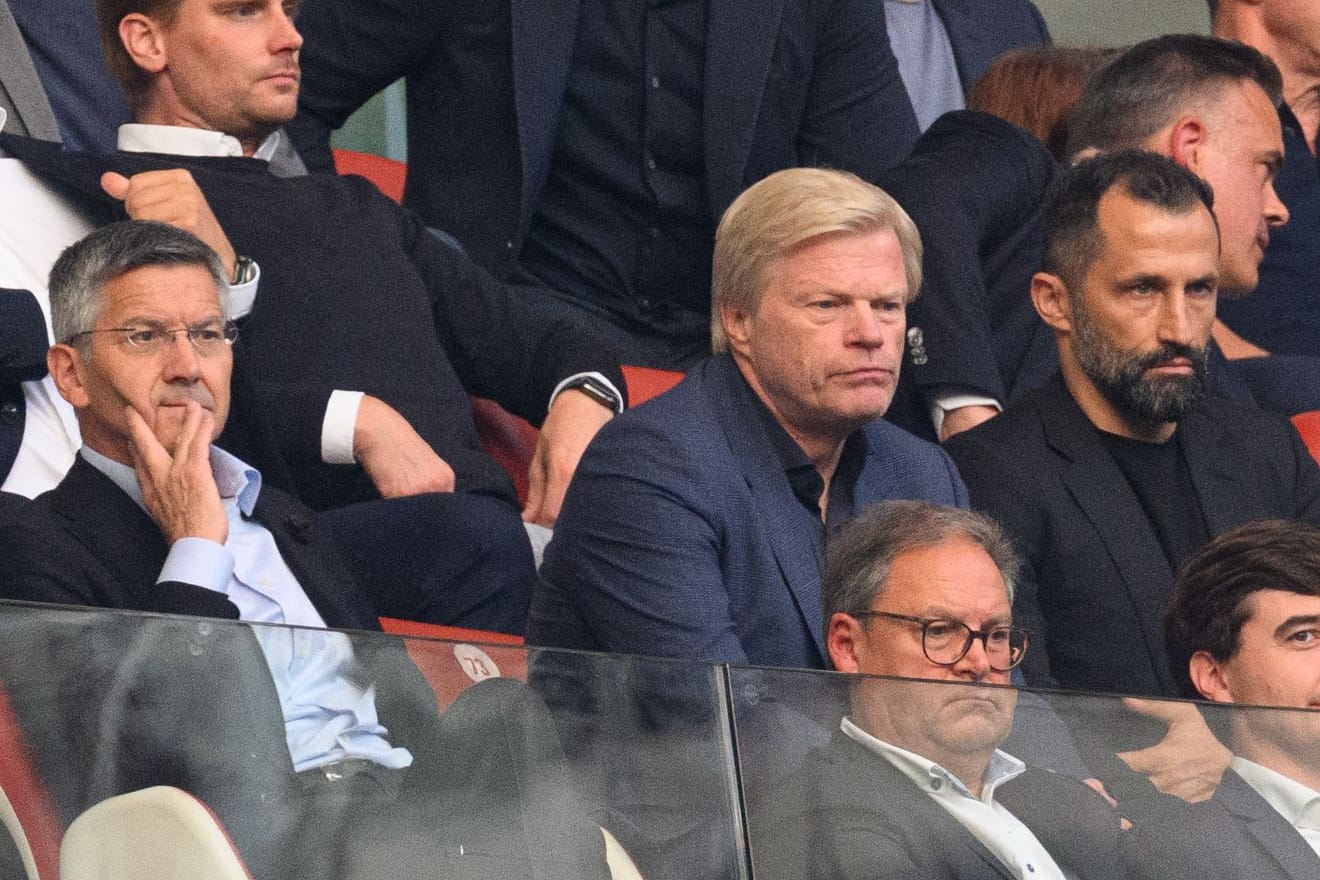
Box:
513 0 714 350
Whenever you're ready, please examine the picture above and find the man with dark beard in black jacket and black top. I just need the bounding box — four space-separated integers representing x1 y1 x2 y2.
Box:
948 152 1320 695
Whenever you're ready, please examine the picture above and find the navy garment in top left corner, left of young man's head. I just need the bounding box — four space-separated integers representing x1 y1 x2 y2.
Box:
8 0 133 153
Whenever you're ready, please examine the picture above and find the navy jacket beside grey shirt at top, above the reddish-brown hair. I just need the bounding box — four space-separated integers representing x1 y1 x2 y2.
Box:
932 0 1049 92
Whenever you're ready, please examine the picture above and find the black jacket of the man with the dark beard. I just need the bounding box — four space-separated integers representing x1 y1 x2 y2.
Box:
948 376 1320 697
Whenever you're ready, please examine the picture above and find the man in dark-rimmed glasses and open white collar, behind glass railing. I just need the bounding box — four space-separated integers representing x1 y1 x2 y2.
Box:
750 501 1121 880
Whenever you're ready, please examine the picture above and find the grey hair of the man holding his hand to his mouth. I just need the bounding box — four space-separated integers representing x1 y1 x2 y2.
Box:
48 220 230 343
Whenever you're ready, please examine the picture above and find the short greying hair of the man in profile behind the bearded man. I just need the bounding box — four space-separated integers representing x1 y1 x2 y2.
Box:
1068 33 1283 156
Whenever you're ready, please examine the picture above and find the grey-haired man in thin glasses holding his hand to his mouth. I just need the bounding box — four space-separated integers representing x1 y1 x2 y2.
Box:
0 222 603 877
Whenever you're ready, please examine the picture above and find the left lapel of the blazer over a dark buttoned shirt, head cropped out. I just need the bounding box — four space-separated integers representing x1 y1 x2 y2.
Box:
512 0 578 224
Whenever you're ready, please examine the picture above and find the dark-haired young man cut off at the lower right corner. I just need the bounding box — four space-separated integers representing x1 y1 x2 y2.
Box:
1131 520 1320 880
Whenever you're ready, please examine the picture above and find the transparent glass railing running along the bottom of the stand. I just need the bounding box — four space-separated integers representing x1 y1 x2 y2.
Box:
0 604 1320 880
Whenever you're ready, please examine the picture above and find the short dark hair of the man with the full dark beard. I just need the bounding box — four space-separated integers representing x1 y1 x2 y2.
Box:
1041 150 1218 290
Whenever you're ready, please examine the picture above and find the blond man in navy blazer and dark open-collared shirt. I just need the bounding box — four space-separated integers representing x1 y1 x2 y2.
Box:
528 169 965 668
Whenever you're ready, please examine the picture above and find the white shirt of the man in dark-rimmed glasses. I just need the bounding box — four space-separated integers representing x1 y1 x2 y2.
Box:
840 718 1072 880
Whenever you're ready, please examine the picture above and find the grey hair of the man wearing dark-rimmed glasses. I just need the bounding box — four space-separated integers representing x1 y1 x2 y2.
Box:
821 501 1019 631
